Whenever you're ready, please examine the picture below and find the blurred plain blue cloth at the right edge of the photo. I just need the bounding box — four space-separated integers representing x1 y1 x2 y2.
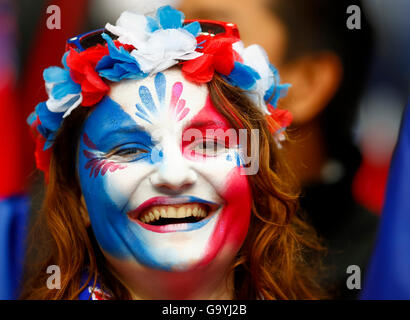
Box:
361 104 410 300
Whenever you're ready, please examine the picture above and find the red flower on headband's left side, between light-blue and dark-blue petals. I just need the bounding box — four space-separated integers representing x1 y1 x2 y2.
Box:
67 45 109 106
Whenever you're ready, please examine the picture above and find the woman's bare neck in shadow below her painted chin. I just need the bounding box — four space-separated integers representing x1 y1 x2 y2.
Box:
104 257 234 300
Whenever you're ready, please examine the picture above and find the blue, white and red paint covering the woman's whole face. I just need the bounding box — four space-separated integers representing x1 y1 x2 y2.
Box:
78 69 251 270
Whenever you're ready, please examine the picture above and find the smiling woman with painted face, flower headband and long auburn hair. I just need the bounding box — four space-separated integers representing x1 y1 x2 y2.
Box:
22 6 322 299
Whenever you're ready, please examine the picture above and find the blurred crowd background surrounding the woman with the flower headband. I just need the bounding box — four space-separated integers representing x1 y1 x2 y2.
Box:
0 0 410 299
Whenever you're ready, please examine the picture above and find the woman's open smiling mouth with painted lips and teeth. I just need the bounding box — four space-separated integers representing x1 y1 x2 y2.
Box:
128 197 220 231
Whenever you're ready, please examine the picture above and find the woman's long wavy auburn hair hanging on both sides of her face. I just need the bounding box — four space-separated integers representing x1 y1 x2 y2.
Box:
21 76 325 299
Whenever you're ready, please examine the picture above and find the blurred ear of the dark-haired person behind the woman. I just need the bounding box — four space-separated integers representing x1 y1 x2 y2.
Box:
280 52 343 125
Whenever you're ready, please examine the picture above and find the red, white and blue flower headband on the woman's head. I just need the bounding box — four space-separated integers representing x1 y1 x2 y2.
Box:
28 6 292 179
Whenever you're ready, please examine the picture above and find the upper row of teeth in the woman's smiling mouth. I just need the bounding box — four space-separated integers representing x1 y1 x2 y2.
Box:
139 203 207 223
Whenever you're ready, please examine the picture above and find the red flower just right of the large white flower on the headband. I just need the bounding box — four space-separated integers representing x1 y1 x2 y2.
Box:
182 36 238 83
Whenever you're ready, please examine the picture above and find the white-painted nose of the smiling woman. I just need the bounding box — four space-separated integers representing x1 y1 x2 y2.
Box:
150 141 197 194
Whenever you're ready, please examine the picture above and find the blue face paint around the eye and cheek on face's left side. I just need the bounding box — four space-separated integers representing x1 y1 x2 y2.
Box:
78 97 163 261
